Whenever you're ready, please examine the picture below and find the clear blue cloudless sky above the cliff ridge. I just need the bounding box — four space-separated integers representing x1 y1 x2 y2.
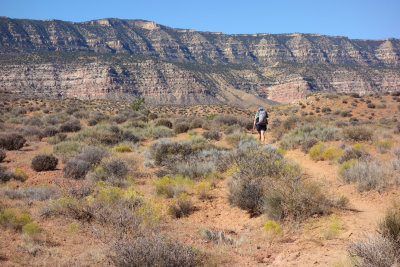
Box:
0 0 400 39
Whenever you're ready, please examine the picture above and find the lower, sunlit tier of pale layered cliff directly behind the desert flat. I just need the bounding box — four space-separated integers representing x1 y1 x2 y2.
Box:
0 52 400 106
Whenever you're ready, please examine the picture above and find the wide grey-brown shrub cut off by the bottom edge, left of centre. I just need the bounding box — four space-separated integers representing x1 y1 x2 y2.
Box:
112 234 201 267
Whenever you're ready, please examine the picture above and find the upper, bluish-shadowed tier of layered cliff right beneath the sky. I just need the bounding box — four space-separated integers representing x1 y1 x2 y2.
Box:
0 17 400 67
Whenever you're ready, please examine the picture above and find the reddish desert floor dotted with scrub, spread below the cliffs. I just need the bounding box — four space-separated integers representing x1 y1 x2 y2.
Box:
0 92 400 266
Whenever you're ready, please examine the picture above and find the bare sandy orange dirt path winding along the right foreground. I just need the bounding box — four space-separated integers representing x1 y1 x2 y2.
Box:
282 150 398 266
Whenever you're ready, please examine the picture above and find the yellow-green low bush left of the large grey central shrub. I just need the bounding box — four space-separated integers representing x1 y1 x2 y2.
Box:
153 175 193 198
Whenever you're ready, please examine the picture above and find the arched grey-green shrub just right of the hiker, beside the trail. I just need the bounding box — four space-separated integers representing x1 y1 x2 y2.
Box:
280 124 340 149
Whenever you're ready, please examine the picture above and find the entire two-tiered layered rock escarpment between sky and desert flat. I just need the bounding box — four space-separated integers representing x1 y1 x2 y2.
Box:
0 17 400 105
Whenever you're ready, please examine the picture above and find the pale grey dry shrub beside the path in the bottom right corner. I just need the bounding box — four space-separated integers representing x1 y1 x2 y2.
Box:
347 235 398 267
